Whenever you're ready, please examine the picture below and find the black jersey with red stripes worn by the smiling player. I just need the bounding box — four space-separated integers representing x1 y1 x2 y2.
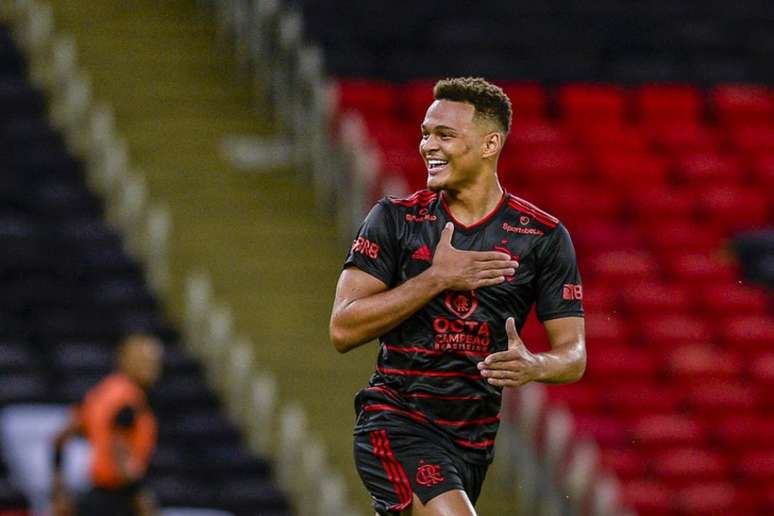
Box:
344 190 583 462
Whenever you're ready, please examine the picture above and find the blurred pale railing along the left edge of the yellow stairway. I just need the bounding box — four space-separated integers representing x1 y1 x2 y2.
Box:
0 0 354 516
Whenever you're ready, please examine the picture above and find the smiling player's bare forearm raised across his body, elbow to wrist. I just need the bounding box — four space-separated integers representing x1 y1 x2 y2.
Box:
331 269 444 353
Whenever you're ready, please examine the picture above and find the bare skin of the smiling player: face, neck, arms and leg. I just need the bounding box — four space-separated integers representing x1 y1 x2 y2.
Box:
330 100 586 516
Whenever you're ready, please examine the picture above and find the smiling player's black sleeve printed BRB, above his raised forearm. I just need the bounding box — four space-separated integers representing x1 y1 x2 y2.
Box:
344 200 398 286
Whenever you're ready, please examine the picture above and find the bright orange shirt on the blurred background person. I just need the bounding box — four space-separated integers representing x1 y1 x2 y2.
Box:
76 373 157 489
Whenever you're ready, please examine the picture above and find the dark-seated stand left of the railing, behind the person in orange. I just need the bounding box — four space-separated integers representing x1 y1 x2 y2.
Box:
0 18 291 516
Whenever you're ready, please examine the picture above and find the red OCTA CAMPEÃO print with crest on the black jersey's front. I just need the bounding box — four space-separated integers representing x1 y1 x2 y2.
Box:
433 290 491 351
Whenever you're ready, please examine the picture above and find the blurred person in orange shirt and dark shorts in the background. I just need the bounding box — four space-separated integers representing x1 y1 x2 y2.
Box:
53 334 163 516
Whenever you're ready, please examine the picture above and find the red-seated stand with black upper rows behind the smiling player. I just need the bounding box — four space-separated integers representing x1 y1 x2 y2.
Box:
297 1 774 515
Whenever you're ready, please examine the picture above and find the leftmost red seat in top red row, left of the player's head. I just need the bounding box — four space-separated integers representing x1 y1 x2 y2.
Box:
334 79 398 118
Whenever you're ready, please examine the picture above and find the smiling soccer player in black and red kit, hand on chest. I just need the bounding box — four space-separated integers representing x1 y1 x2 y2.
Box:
330 77 586 516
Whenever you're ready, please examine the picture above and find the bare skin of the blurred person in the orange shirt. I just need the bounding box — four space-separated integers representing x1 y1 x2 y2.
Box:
52 335 162 516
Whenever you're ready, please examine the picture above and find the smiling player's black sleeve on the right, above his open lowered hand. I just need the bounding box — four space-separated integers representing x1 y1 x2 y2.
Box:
536 224 583 321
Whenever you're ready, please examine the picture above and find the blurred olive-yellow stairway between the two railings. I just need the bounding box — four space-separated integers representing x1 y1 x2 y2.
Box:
44 0 384 513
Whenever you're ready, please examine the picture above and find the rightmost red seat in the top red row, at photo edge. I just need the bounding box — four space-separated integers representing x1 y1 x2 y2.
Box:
709 85 774 124
